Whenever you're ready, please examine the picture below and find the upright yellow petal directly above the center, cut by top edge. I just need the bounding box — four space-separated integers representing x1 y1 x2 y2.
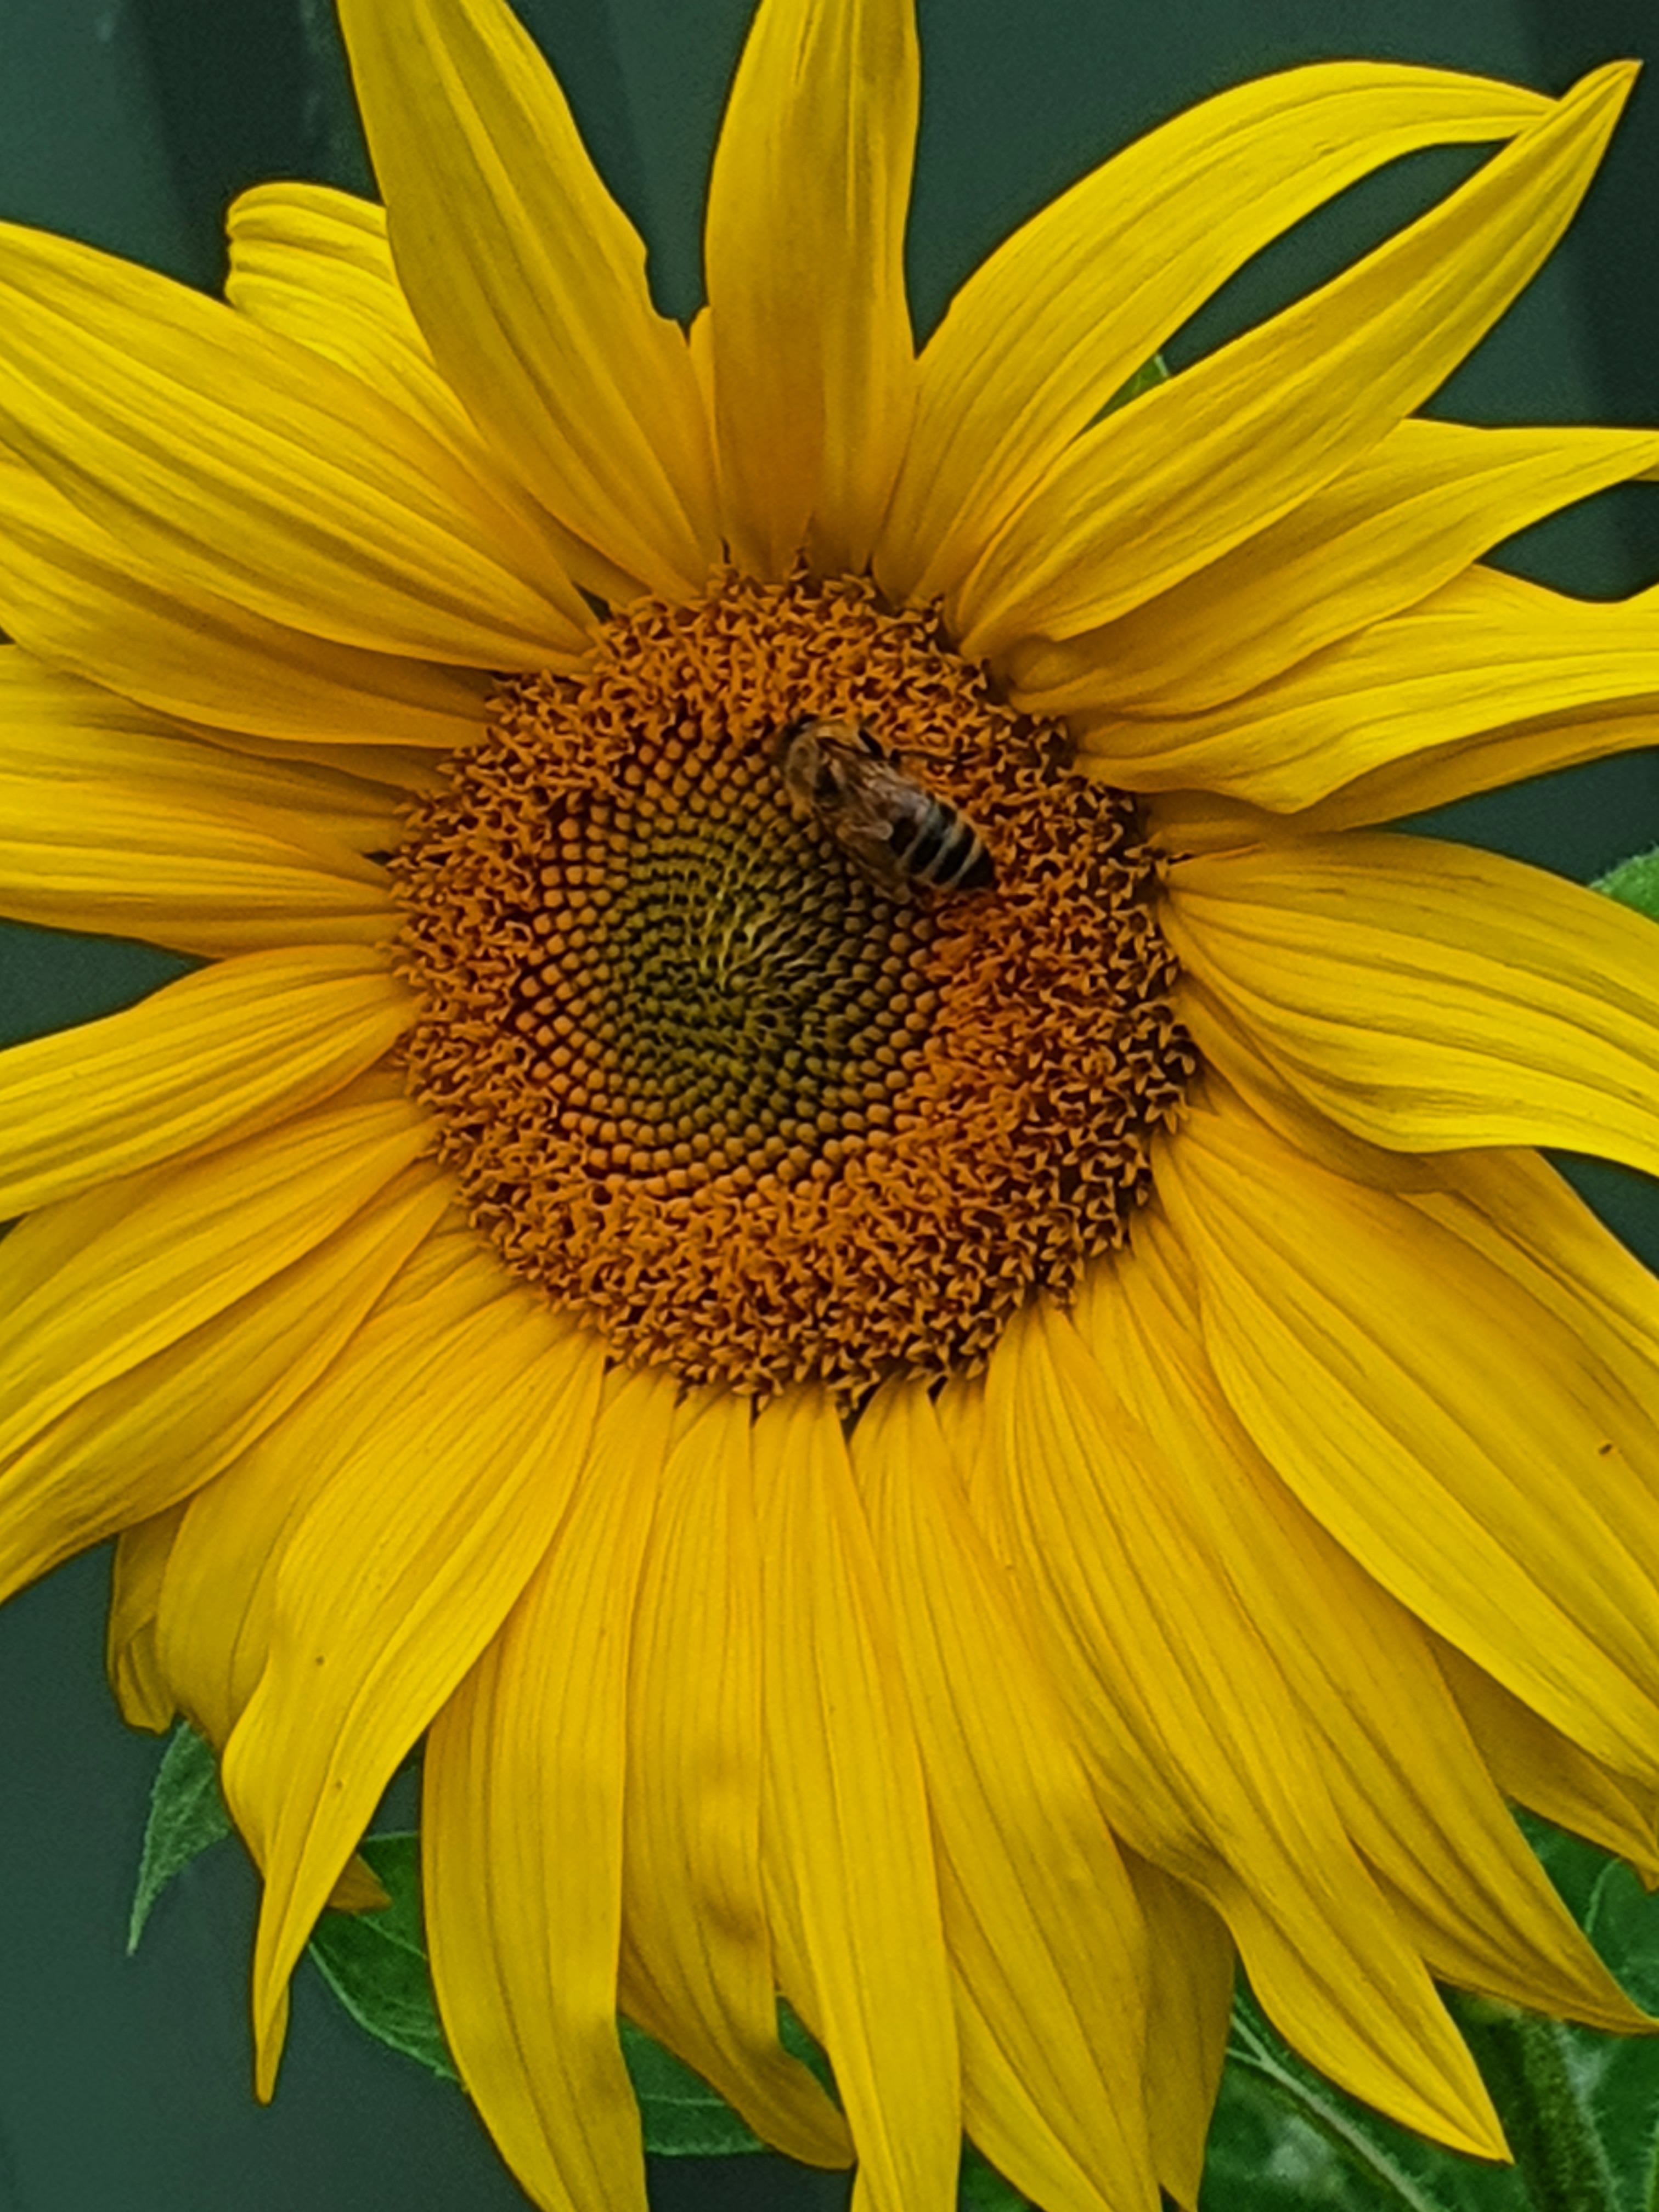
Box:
706 0 920 577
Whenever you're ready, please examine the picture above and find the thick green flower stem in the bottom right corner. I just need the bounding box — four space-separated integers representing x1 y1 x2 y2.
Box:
1453 1997 1619 2212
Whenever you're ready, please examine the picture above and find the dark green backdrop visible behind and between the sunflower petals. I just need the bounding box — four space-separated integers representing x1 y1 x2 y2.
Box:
0 0 1659 2212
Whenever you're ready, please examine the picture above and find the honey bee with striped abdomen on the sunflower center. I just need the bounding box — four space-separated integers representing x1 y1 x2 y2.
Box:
776 714 997 891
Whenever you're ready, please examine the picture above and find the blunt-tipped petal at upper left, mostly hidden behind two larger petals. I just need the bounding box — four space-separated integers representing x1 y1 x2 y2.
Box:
225 184 641 619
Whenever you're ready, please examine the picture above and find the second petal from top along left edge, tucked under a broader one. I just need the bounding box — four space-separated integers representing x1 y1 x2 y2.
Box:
0 456 493 750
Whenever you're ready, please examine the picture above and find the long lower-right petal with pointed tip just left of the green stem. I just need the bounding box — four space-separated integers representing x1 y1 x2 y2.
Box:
989 1307 1502 2157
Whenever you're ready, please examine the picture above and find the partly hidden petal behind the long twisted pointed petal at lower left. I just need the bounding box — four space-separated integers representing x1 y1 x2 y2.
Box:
157 1221 504 1745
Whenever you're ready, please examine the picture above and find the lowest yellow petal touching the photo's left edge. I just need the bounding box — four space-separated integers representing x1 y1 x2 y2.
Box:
0 1168 447 1590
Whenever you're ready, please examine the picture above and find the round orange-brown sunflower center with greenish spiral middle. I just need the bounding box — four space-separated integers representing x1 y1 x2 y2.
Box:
394 577 1194 1398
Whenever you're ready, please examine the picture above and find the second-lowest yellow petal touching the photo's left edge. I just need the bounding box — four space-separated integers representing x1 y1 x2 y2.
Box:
0 1099 431 1520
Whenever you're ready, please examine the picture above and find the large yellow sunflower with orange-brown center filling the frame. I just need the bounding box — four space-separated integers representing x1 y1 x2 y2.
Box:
0 0 1659 2212
